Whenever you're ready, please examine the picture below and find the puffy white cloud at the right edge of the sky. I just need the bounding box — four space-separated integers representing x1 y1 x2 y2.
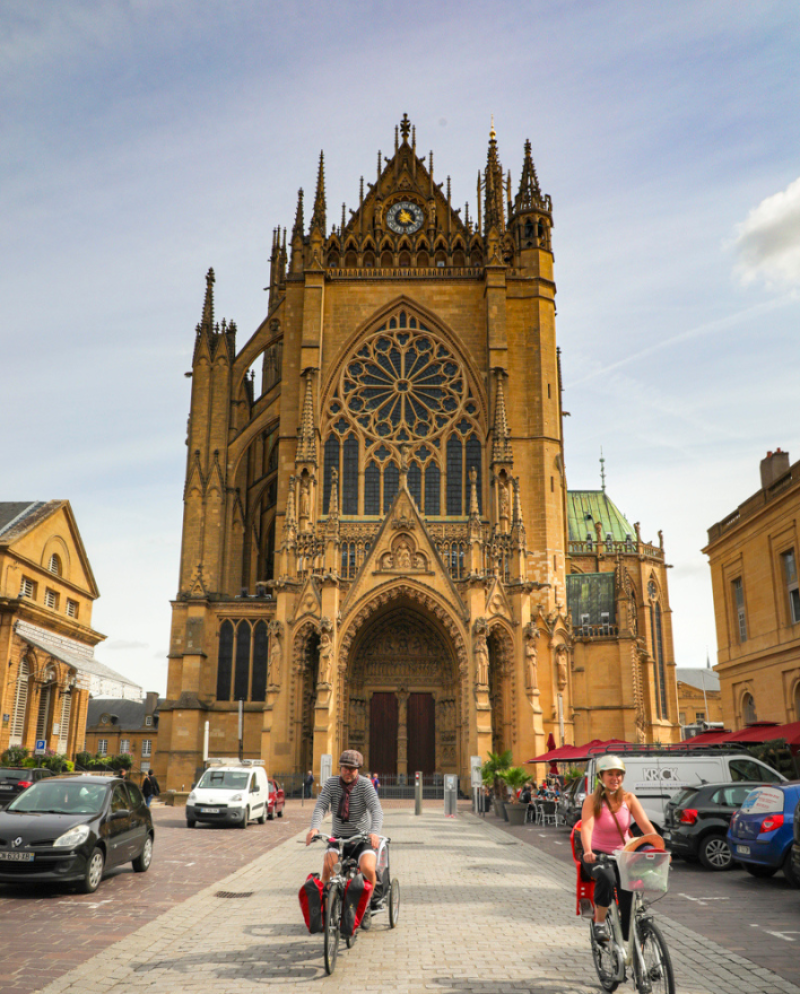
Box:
733 178 800 289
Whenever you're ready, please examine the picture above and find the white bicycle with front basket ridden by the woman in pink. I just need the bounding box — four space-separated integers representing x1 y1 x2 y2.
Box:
589 850 675 994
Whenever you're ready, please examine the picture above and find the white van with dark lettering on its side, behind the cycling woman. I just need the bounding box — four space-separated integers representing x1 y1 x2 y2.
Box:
586 746 786 832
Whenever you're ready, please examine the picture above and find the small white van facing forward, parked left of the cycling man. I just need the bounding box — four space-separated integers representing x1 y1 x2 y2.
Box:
186 760 269 828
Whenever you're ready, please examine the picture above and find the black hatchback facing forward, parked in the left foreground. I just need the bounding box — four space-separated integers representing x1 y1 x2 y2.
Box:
0 776 154 894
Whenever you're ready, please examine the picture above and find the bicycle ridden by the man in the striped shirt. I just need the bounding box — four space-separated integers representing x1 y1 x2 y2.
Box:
313 832 400 975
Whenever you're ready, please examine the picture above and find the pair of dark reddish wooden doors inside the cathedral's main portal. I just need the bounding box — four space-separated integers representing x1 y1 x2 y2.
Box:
369 692 436 775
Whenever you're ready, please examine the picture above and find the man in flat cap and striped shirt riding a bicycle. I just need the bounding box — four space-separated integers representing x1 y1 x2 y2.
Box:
306 749 383 912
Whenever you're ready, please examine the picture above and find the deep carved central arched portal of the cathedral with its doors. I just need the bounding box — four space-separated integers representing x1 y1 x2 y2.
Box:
343 604 460 775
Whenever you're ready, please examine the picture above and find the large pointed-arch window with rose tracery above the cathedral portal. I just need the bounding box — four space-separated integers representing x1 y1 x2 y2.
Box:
322 307 485 518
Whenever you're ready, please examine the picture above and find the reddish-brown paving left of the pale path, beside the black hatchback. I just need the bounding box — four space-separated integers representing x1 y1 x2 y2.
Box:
0 801 311 994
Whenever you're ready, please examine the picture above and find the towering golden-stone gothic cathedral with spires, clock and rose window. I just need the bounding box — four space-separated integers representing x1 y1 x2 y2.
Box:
159 117 677 787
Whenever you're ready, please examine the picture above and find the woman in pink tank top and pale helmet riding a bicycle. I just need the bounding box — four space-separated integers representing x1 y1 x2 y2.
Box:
580 756 663 942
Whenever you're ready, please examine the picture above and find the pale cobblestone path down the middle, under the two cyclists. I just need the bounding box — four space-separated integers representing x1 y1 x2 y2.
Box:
23 805 800 994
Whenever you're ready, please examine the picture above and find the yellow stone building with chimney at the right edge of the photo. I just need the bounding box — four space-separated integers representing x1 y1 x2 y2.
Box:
703 449 800 731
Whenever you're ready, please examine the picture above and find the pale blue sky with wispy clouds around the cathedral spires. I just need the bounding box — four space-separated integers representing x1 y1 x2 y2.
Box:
0 0 800 692
